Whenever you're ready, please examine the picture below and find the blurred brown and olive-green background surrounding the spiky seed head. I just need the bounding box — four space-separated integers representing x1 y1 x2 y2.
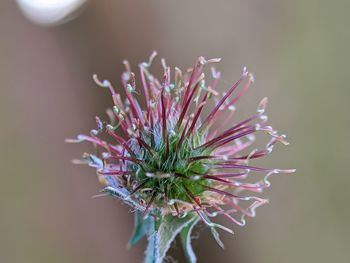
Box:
0 0 350 263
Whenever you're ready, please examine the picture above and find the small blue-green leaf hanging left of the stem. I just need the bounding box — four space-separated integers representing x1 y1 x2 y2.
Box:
128 211 154 248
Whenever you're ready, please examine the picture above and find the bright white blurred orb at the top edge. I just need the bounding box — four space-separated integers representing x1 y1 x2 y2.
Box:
17 0 86 26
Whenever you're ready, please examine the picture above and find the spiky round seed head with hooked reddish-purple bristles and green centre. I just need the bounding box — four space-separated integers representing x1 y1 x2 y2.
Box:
68 52 294 262
